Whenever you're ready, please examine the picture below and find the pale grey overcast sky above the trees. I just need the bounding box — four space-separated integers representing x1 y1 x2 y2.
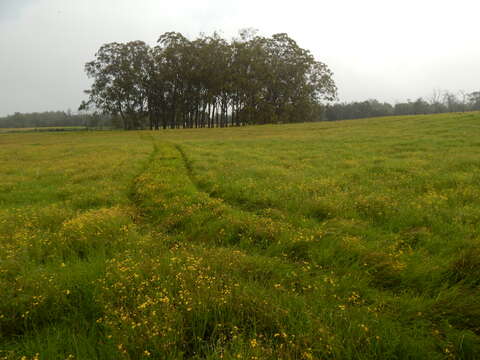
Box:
0 0 480 116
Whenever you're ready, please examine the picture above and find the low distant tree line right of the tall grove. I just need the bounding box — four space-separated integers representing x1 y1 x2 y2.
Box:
325 90 480 120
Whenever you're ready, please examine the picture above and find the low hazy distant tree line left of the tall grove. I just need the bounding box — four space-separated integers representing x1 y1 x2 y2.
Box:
0 111 114 129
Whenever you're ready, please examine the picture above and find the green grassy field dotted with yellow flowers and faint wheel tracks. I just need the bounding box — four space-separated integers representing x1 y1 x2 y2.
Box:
0 113 480 360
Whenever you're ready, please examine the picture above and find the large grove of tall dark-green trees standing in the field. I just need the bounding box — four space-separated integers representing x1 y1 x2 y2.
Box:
80 30 337 130
